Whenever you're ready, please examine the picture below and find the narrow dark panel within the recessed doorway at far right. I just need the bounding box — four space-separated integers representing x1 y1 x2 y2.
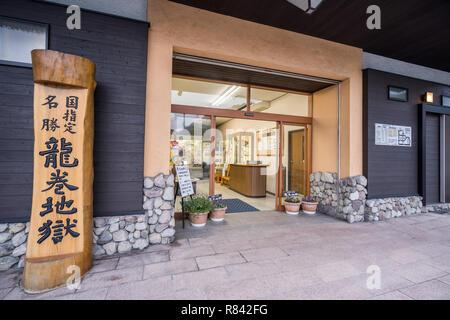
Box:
425 113 441 203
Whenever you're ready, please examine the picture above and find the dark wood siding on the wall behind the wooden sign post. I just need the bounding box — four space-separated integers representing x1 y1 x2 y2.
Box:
0 0 148 221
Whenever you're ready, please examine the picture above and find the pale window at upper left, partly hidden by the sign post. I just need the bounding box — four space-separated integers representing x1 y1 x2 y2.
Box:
0 16 48 66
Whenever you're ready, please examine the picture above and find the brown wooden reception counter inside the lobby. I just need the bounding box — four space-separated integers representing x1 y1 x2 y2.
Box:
230 164 268 198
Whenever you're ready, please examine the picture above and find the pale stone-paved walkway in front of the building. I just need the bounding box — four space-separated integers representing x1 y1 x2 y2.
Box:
0 212 450 299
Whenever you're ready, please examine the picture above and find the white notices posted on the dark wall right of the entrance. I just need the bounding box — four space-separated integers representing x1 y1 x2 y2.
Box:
375 123 412 147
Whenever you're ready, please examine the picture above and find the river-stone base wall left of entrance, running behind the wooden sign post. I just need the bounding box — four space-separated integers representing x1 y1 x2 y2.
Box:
0 174 175 271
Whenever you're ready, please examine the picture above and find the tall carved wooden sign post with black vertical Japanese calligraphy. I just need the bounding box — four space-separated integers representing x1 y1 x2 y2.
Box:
22 50 96 292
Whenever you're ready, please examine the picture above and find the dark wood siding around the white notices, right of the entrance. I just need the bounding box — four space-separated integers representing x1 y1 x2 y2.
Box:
363 69 450 198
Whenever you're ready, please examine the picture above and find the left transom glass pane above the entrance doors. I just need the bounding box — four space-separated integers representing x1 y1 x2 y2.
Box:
172 77 247 110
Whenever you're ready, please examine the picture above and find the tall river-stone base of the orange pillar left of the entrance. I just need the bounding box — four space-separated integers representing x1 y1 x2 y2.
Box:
144 174 175 244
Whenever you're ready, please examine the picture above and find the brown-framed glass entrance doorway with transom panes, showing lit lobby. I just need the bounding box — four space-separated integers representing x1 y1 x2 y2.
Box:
171 77 312 212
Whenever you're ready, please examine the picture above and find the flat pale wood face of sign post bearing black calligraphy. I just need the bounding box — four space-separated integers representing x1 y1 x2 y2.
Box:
30 84 87 256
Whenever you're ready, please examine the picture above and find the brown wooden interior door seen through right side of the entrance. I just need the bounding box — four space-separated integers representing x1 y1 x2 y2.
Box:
288 129 306 195
